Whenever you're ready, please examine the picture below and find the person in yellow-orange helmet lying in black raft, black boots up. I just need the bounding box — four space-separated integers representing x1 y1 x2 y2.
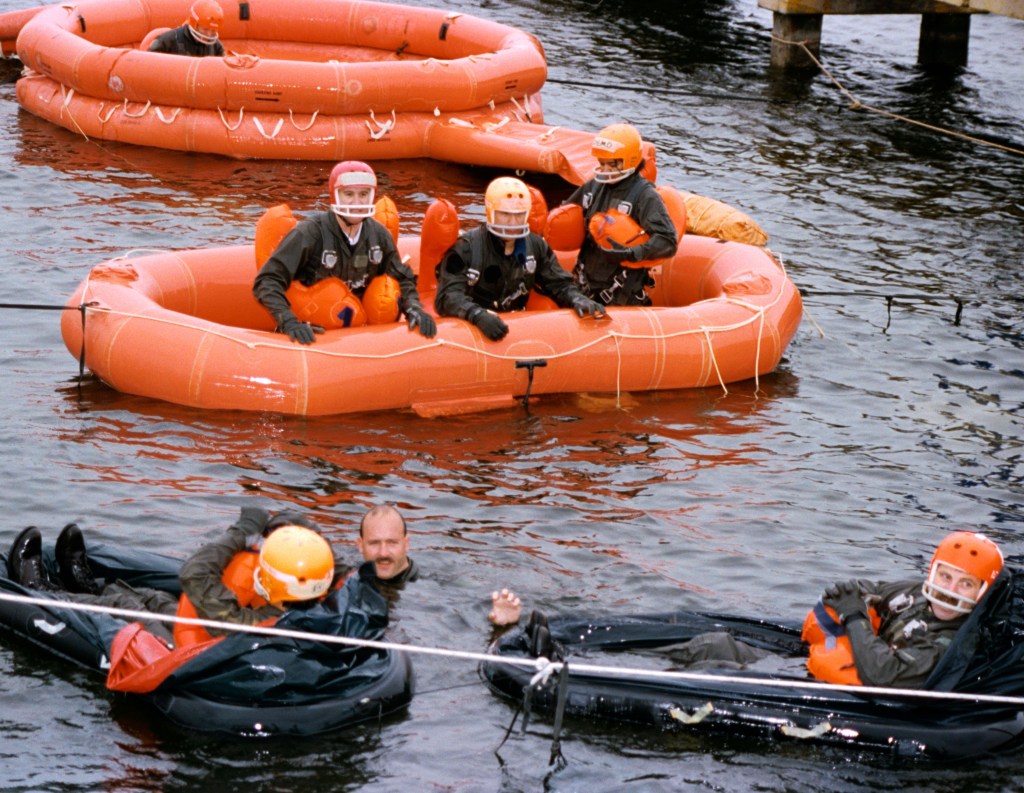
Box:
7 507 346 646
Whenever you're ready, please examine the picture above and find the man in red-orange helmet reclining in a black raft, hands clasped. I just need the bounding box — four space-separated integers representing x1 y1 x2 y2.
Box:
489 532 1002 688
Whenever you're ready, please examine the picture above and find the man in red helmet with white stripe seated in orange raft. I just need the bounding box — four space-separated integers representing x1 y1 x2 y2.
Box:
253 160 437 344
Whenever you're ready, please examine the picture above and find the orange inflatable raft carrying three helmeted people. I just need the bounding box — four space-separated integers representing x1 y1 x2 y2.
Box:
61 234 802 416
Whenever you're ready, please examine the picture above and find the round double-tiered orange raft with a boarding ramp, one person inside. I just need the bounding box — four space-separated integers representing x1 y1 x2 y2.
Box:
9 0 653 184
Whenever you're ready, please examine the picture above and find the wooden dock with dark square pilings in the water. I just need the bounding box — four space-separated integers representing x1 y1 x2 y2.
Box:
758 0 1024 69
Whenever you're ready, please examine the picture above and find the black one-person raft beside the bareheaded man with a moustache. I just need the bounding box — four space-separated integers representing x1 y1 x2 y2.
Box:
0 545 413 737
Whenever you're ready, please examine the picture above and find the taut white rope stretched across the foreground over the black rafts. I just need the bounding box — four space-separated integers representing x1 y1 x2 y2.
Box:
0 592 1024 707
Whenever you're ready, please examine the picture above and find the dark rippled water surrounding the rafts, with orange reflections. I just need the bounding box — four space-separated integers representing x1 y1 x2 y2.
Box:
0 0 1024 793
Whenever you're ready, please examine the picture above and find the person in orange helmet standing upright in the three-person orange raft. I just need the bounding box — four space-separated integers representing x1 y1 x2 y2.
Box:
565 124 679 305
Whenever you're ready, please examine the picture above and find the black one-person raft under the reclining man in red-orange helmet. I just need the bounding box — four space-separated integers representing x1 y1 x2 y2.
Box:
480 571 1024 759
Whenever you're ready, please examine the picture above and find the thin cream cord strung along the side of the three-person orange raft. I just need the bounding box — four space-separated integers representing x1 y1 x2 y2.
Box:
83 249 785 393
